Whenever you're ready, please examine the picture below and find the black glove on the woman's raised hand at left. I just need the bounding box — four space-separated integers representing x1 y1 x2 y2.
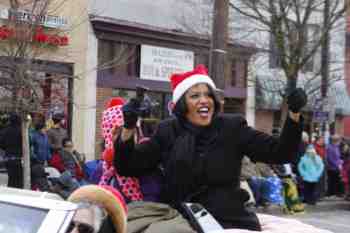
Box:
122 98 140 129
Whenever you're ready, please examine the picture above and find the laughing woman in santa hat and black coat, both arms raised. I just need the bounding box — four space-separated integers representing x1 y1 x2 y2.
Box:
114 65 307 231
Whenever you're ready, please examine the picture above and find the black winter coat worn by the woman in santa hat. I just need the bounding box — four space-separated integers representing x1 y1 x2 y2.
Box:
114 114 302 230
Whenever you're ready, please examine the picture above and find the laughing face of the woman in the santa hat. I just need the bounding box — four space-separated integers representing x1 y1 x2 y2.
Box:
185 83 215 126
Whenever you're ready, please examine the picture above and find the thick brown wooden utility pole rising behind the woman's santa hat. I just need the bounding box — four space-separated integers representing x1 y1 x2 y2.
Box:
209 0 229 90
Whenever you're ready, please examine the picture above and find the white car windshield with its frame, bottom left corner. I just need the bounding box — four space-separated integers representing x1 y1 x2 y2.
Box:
0 187 77 233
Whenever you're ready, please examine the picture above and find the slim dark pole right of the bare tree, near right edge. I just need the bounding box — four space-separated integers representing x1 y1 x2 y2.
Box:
321 0 330 142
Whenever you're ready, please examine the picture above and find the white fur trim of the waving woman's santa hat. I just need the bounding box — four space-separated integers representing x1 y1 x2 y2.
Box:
173 74 216 104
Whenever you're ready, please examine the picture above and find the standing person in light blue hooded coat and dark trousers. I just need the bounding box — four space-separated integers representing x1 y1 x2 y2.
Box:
298 145 324 205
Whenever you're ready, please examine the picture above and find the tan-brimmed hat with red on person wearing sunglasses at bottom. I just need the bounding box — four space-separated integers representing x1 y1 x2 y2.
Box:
68 185 127 233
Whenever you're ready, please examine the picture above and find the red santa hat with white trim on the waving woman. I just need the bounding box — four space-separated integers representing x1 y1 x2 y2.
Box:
170 65 216 104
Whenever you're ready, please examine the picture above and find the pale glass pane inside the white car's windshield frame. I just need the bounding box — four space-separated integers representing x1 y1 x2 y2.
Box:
0 202 48 233
